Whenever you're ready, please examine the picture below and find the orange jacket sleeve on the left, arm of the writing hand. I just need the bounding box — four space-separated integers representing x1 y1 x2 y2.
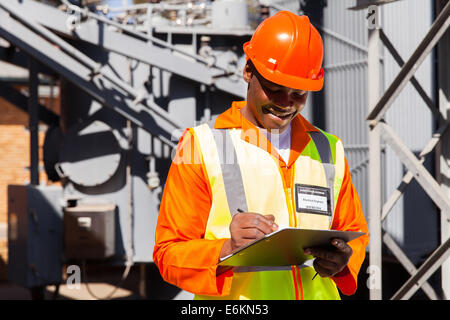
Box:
153 129 233 296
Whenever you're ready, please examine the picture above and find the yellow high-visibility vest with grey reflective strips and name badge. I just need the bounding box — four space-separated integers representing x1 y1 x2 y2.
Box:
193 122 345 300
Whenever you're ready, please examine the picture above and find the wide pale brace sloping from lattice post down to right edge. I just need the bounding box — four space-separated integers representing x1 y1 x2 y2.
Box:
376 122 450 219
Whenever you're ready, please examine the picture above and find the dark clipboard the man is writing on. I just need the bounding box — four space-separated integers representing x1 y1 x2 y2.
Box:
217 228 365 267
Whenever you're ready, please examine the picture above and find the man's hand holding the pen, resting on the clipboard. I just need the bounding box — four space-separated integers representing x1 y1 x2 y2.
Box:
220 212 278 258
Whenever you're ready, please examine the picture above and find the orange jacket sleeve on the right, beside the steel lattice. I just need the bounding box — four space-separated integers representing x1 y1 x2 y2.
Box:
331 159 369 295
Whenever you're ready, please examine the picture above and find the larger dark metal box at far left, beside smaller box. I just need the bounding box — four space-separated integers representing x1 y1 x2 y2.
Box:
8 185 63 288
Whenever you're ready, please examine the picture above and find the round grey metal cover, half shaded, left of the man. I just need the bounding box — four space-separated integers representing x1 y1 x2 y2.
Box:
55 120 121 187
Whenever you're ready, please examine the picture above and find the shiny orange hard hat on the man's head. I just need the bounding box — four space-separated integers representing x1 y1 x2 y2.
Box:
244 11 324 91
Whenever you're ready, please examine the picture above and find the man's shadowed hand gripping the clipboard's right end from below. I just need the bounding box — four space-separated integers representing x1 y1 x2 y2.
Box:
305 239 353 278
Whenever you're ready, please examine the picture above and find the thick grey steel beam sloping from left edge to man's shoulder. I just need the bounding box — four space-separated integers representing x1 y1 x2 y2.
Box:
0 4 181 147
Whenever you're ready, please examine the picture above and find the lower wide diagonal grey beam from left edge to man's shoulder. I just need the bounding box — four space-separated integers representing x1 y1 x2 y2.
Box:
0 9 181 147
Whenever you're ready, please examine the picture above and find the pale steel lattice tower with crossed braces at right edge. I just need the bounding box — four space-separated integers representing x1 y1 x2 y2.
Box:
367 2 450 300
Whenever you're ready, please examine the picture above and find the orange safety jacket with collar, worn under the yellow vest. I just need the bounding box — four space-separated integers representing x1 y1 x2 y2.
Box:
153 101 368 298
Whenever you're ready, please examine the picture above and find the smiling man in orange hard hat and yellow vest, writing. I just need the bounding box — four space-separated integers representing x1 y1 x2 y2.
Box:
153 11 368 300
